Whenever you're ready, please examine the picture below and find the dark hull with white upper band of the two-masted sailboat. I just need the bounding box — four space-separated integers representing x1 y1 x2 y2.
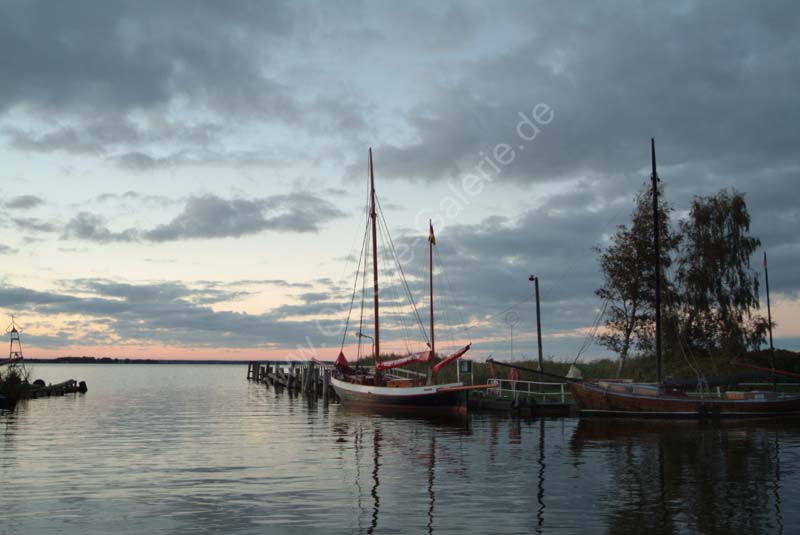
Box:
331 378 467 413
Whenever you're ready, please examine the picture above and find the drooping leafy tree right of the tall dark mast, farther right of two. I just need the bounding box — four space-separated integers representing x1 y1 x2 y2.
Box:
678 190 767 363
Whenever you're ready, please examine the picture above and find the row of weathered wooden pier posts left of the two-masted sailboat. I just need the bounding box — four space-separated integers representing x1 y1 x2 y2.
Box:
247 360 336 400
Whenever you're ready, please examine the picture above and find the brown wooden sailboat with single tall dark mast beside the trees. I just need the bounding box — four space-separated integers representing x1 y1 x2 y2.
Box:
570 139 800 417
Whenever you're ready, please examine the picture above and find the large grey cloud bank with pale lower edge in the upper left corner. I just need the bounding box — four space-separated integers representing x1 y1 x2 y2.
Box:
0 1 365 161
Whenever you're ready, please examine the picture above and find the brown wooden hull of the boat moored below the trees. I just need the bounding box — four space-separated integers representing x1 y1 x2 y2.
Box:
570 383 800 418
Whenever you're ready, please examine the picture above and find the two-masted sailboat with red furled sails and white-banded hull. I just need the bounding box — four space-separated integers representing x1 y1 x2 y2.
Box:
331 148 491 412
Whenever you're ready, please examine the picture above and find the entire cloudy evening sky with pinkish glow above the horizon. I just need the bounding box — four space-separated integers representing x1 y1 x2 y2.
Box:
0 0 800 359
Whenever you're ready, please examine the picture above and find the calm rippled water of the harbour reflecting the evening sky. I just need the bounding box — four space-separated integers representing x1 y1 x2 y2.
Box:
0 364 800 534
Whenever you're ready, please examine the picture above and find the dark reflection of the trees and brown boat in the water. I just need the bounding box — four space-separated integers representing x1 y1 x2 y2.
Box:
570 419 797 534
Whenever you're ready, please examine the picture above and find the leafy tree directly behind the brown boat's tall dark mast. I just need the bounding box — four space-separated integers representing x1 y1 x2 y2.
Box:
595 187 678 377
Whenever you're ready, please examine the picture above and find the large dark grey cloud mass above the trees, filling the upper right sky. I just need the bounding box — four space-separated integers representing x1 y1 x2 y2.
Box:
356 2 800 348
